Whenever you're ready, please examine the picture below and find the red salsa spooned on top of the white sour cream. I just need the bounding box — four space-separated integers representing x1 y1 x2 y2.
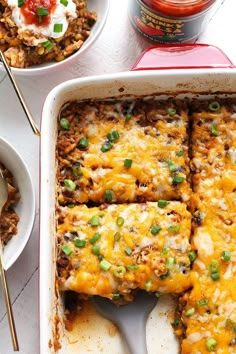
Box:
20 0 56 26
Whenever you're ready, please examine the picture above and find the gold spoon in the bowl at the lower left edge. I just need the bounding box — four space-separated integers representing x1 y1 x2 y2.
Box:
0 168 19 351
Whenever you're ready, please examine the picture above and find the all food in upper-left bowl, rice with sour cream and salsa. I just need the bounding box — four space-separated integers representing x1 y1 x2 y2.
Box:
0 0 97 68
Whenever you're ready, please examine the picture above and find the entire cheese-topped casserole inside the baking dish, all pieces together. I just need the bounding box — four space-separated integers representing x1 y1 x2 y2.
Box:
56 97 236 354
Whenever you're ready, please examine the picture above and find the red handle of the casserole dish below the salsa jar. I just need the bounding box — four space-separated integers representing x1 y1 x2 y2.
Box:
131 43 235 70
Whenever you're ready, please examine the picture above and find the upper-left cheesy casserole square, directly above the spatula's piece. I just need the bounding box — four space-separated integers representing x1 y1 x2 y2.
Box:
56 98 190 205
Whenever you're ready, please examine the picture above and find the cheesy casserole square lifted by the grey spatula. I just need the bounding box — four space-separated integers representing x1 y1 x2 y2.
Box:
57 202 191 301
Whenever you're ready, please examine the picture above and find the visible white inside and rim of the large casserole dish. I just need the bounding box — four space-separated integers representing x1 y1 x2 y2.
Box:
40 51 236 354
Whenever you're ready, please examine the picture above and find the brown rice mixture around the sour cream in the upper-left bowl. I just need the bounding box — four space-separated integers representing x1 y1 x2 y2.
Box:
0 0 97 68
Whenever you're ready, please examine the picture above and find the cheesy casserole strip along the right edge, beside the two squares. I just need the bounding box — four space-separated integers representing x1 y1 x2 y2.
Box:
182 103 236 354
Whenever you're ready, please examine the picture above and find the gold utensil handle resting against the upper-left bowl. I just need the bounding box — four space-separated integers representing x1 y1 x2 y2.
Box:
0 50 40 136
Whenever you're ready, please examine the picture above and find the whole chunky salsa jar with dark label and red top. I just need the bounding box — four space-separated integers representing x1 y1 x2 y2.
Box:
129 0 217 43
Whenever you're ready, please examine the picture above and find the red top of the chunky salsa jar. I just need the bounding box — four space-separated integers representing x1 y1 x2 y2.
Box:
143 0 216 17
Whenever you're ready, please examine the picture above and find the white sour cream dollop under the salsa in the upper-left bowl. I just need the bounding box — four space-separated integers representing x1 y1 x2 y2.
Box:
7 0 77 40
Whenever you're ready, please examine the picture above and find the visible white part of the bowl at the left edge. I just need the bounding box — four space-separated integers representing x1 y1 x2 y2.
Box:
0 137 35 270
